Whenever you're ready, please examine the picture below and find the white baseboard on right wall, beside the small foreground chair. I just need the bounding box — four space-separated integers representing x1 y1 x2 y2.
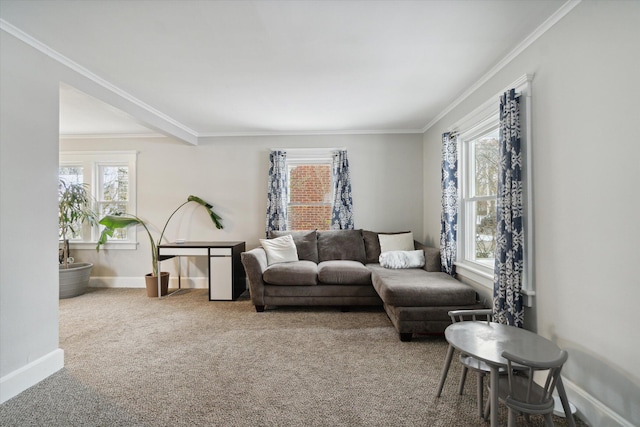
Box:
562 376 636 427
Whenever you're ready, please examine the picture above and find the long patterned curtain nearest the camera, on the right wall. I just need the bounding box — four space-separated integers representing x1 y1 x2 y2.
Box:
493 89 524 328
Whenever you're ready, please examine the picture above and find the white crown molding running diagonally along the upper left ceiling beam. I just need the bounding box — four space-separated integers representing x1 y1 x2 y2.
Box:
0 18 198 142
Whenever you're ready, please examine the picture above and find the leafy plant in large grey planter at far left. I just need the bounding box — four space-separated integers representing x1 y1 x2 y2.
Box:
58 180 98 299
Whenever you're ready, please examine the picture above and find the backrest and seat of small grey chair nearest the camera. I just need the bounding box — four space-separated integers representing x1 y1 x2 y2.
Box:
502 350 569 413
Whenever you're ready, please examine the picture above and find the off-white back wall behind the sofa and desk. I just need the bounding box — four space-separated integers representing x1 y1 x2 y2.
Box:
60 135 423 286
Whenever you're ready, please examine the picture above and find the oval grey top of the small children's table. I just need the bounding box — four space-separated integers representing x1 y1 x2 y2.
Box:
444 322 560 366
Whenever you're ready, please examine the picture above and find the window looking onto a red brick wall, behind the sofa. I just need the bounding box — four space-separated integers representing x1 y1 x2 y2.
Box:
287 149 333 230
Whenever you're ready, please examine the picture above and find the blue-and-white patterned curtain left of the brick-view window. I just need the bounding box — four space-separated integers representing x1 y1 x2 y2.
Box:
266 150 289 237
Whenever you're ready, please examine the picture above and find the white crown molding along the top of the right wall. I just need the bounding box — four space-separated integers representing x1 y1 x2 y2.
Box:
422 0 582 133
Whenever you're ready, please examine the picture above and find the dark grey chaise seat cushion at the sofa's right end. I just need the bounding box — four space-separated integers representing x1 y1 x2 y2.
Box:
367 264 476 307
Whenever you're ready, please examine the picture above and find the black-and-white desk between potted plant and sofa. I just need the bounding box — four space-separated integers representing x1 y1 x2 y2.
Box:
158 242 247 301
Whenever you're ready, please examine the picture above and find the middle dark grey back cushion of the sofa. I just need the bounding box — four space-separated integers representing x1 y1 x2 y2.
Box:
318 230 367 264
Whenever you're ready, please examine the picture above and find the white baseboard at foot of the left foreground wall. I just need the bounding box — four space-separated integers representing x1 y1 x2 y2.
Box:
0 348 64 403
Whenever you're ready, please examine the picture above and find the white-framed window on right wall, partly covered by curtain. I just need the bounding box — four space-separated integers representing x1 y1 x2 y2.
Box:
452 75 535 306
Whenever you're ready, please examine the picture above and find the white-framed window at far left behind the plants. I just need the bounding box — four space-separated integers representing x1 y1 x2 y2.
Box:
58 151 136 249
